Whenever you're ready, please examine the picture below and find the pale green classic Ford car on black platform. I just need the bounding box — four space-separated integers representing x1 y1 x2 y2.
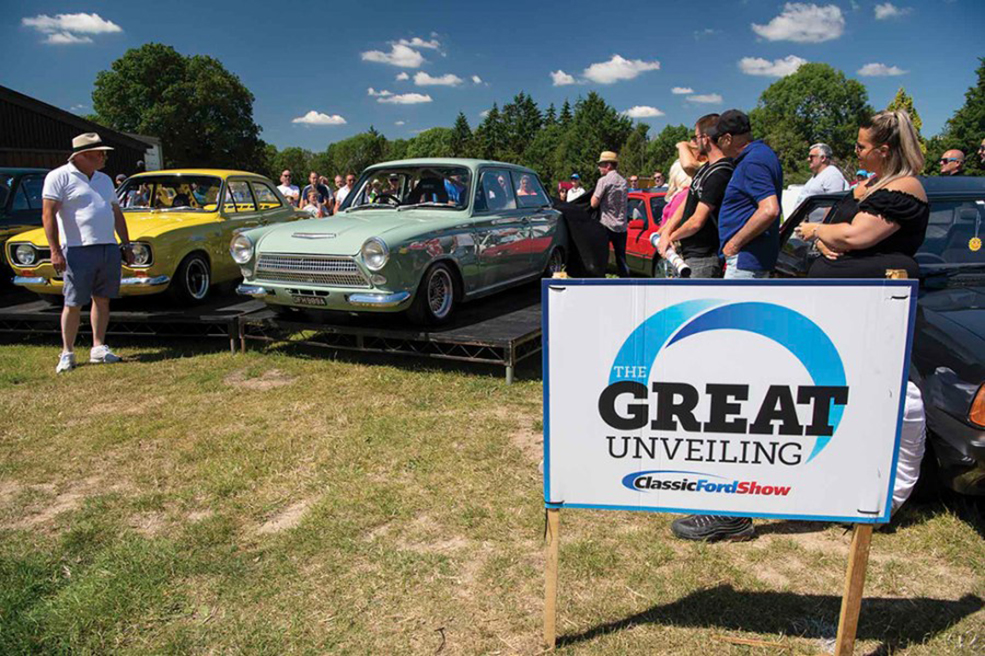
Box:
230 159 567 325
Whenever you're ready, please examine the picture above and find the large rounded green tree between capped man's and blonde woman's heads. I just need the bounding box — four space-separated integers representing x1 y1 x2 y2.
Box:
749 63 872 183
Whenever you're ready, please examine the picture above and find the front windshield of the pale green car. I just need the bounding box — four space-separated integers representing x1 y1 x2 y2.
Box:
348 166 472 210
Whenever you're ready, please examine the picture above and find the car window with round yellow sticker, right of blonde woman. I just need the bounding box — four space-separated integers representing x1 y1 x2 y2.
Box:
916 198 985 269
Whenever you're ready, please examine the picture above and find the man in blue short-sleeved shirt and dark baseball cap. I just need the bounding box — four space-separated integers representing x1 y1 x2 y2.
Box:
716 109 783 279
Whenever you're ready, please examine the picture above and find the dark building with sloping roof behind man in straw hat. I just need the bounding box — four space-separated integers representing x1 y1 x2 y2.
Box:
0 86 160 177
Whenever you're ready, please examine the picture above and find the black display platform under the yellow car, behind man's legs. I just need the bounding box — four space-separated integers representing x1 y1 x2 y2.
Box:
0 294 264 352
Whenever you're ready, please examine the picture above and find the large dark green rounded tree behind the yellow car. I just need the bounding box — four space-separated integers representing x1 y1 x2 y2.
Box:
92 43 267 171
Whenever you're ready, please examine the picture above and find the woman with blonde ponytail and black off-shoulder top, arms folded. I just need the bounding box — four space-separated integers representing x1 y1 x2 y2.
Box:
797 111 930 278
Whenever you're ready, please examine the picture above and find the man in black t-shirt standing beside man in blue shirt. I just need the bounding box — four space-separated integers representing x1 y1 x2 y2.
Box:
657 114 734 278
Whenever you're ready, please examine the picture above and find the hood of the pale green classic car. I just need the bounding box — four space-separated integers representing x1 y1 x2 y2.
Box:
258 210 454 255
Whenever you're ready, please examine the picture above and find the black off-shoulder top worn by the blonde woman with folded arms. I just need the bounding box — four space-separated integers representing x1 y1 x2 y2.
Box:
808 189 930 278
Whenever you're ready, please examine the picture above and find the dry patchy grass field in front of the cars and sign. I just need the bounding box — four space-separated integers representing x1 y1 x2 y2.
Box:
0 341 985 656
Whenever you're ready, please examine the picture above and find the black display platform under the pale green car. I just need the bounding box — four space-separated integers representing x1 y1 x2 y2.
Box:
239 285 541 384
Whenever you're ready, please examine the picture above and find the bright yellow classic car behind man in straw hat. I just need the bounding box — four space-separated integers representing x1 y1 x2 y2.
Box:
4 169 309 303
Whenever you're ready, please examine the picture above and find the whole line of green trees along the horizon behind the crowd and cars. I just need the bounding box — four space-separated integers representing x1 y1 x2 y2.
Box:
89 43 985 186
